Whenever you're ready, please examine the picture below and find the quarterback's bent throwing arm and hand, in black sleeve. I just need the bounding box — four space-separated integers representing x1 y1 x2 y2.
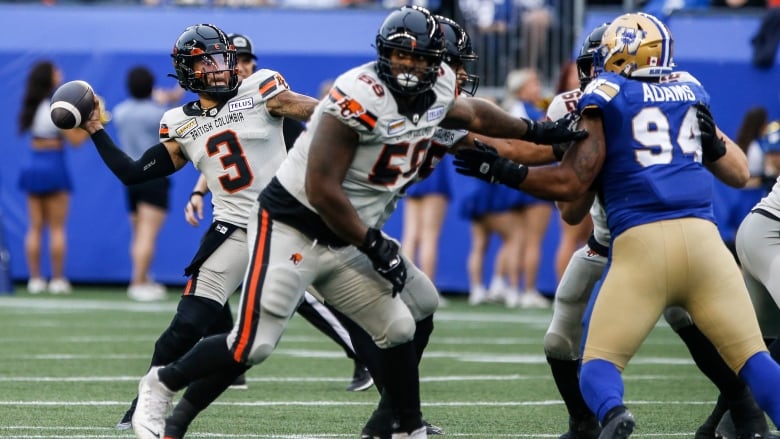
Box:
81 98 187 185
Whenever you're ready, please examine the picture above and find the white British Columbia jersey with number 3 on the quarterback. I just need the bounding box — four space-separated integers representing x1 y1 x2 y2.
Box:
160 69 289 228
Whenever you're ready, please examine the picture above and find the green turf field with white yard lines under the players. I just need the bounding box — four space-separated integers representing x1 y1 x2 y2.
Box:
0 288 768 438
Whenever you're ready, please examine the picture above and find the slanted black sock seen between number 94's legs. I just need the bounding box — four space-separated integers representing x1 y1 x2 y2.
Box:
677 325 747 401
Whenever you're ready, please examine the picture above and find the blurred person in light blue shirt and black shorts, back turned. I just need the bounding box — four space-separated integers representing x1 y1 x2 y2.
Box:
114 66 178 302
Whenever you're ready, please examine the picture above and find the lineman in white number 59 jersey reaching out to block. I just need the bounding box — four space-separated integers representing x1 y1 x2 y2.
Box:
126 7 586 439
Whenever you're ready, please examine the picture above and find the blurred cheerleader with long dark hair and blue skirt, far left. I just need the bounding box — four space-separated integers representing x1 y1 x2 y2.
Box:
18 61 89 294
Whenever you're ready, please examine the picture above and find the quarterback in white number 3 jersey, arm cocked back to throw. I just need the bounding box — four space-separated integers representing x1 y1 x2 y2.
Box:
78 24 317 434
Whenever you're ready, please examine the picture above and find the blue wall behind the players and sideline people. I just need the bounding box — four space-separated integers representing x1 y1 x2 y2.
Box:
0 5 780 293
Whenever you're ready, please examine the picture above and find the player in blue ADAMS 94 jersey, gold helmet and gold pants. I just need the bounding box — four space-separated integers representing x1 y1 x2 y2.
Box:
455 13 780 439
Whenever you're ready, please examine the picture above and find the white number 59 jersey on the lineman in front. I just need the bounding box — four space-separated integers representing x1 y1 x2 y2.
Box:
277 62 457 228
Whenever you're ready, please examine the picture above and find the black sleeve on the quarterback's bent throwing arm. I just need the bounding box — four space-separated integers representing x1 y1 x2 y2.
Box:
92 130 176 185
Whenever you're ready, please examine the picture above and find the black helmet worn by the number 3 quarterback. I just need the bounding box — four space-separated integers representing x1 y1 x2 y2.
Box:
171 24 238 100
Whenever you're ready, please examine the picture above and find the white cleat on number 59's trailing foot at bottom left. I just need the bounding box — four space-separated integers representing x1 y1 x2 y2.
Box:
133 366 176 439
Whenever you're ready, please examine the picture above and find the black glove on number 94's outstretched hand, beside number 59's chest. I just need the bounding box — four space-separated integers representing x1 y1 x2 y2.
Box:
453 139 528 189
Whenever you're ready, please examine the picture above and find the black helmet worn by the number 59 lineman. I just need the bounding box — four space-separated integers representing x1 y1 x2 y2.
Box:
376 6 444 96
